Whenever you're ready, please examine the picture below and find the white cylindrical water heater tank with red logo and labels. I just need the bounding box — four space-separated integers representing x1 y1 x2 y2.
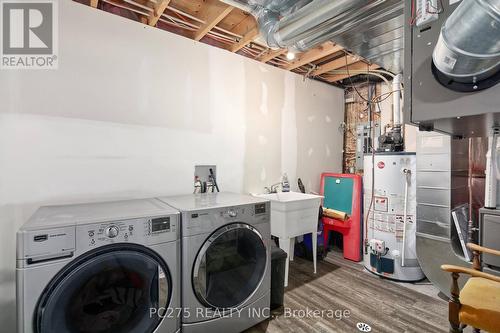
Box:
363 152 425 281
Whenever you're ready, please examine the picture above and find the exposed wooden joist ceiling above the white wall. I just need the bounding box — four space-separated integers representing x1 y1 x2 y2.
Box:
74 0 381 85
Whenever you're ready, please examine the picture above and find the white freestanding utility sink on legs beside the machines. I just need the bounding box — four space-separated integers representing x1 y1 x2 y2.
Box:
257 192 323 287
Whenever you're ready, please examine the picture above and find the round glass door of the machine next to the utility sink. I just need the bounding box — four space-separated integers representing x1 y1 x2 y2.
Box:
193 223 267 309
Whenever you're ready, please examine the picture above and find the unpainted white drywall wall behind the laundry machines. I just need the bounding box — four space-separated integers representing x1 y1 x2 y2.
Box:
0 1 344 332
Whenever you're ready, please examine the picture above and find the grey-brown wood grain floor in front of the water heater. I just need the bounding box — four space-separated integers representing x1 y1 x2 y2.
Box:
245 254 448 333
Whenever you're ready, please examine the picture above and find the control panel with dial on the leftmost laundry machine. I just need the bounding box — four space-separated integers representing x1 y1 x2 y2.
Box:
76 215 179 251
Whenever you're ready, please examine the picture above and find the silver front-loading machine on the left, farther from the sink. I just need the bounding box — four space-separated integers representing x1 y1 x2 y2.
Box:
16 199 180 333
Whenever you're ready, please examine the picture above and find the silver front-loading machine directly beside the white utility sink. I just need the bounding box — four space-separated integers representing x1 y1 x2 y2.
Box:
160 193 271 333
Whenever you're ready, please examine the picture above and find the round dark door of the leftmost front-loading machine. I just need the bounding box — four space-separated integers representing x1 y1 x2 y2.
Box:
34 244 171 333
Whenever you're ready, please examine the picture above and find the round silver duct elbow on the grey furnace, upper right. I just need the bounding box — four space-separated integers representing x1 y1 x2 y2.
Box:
432 0 500 91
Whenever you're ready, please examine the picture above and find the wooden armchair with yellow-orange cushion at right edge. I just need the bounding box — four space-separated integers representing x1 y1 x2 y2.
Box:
441 243 500 333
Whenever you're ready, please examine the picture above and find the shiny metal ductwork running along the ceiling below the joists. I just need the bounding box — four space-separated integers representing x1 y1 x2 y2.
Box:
221 0 405 73
